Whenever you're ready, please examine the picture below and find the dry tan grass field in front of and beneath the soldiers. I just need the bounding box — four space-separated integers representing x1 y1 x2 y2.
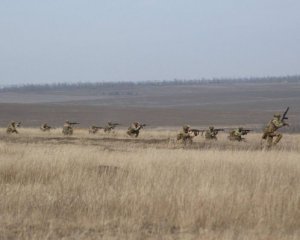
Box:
0 129 300 240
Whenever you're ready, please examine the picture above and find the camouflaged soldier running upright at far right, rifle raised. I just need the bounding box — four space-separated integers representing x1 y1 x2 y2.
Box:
262 114 289 148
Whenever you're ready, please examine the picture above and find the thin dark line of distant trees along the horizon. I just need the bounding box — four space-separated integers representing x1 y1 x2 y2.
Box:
0 75 300 92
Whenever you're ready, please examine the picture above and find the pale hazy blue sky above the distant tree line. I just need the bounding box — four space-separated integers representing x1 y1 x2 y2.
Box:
0 0 300 85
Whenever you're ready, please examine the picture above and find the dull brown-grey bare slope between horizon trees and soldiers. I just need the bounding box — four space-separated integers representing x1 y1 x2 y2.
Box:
0 82 300 127
